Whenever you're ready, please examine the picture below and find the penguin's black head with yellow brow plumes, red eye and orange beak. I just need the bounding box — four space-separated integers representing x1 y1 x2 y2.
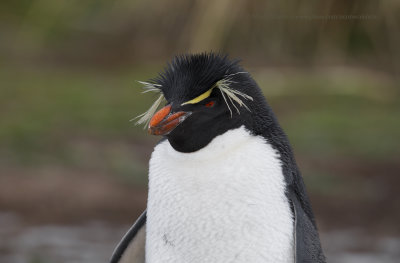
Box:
137 53 269 152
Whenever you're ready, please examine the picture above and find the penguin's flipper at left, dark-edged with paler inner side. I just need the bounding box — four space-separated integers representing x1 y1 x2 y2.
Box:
110 210 146 263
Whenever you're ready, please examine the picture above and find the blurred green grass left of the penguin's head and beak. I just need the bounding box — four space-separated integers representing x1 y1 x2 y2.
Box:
0 66 158 160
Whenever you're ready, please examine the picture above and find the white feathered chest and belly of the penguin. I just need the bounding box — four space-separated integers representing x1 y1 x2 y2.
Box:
146 127 293 263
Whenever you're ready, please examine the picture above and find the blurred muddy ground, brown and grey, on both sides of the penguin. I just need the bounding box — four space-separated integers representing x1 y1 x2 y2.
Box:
0 160 400 263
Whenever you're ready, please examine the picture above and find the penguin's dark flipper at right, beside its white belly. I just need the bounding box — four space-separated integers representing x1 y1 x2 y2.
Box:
291 192 326 263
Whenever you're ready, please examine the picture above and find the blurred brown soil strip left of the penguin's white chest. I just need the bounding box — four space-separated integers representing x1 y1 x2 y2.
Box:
0 168 147 224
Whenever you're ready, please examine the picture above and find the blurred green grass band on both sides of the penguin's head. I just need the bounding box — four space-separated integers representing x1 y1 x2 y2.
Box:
0 66 400 184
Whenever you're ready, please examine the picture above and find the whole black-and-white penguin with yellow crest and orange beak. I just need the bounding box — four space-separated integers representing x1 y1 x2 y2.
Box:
110 53 326 263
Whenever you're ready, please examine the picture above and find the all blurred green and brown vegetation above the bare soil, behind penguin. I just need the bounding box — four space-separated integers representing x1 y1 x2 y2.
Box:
0 0 400 187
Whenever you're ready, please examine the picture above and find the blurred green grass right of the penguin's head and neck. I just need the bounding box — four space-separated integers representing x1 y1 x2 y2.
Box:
256 69 400 160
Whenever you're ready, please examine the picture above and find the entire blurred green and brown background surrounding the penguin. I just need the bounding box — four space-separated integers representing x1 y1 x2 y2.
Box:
0 0 400 263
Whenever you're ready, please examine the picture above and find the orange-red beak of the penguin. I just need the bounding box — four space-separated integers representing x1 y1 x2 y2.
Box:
148 105 192 135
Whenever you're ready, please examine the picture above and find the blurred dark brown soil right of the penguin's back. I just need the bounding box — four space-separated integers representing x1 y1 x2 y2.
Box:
311 160 400 236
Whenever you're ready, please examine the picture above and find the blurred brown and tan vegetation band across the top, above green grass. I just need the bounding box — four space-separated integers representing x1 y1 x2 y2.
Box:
0 0 400 70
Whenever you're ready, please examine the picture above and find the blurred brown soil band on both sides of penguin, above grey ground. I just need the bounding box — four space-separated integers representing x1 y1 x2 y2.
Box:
0 160 400 235
